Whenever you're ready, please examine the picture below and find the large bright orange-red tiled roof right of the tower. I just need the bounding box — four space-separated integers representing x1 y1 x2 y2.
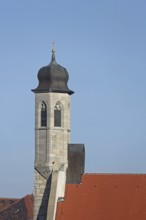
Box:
56 174 146 220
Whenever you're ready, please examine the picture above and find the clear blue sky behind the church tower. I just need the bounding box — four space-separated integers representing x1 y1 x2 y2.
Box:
0 0 146 197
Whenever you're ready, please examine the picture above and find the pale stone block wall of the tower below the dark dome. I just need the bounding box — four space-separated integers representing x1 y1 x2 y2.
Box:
34 92 70 220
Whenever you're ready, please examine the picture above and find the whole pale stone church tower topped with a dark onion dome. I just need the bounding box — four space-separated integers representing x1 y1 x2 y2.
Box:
32 49 74 220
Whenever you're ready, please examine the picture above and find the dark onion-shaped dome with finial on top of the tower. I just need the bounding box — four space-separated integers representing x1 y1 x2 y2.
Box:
32 49 74 95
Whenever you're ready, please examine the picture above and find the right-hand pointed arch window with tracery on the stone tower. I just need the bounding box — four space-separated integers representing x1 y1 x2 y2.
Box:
54 101 62 127
